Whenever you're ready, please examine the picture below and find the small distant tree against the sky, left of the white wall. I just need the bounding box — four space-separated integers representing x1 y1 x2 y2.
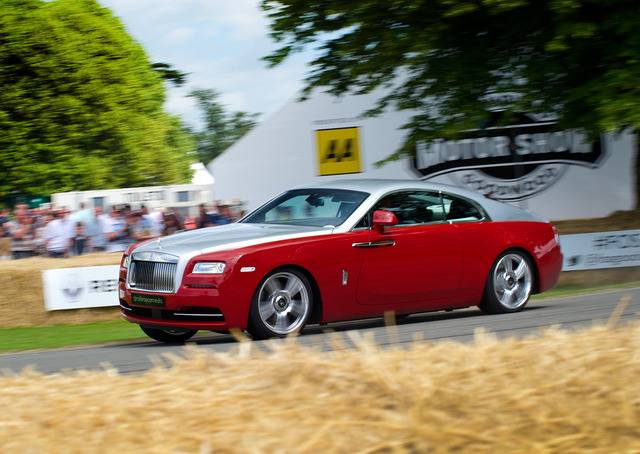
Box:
189 89 259 163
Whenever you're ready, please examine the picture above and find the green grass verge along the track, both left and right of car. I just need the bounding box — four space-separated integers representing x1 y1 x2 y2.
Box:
0 281 640 352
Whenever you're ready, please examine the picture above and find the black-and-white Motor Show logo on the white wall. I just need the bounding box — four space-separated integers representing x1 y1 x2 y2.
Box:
413 117 605 201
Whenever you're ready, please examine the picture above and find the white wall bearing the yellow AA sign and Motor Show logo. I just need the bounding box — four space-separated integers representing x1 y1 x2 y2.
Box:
208 90 637 220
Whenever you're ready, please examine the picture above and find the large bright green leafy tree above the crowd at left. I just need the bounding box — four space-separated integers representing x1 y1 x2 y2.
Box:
0 0 194 198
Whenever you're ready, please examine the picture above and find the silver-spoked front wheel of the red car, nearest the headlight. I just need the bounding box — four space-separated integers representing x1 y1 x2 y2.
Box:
248 268 314 340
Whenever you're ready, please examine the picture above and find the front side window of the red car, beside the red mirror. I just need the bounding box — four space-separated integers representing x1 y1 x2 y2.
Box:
355 191 445 228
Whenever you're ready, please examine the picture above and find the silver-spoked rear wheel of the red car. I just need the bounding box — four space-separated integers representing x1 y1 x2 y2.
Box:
479 251 534 314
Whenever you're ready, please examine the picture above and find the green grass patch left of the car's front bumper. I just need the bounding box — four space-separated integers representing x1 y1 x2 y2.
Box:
0 320 146 352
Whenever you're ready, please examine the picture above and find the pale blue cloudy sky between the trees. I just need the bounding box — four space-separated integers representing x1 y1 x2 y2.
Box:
98 0 309 128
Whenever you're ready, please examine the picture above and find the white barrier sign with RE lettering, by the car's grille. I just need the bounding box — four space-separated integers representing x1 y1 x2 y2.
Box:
42 265 120 311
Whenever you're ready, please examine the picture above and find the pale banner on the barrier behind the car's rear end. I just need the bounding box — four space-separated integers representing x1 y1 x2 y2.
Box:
560 230 640 271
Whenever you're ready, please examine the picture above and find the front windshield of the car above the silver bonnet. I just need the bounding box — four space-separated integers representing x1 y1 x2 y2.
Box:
240 189 369 227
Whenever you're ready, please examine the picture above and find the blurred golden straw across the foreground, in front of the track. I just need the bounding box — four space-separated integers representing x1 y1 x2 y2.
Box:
0 316 640 453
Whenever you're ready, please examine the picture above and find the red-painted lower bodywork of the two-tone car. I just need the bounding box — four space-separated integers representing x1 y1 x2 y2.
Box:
119 182 562 338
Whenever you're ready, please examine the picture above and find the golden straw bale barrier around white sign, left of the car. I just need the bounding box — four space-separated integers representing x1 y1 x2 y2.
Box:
0 253 122 328
